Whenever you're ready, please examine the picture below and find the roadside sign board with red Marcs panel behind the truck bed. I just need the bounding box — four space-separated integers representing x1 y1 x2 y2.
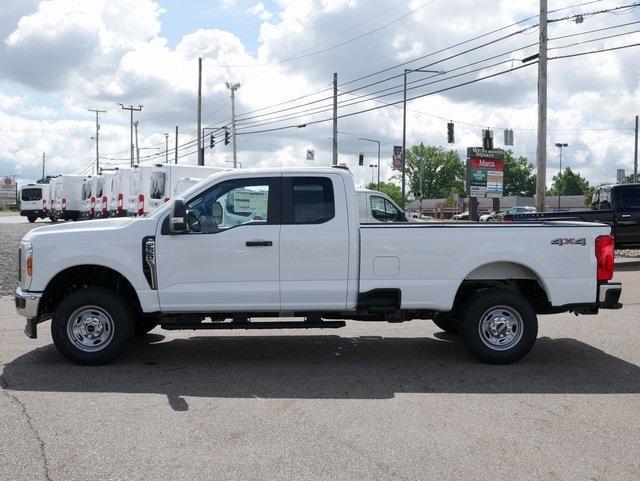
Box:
467 147 504 198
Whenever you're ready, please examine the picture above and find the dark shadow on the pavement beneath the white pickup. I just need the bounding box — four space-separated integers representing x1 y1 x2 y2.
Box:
2 333 640 410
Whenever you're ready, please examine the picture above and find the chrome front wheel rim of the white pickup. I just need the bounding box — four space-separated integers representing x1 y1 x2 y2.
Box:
67 306 114 352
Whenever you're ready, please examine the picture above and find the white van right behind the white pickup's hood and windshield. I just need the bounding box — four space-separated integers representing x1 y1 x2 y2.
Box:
127 164 228 215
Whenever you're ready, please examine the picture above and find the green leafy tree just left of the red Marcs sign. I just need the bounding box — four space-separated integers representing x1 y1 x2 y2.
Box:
406 143 466 199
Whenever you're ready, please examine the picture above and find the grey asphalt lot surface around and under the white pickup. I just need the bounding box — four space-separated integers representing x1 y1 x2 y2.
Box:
0 220 640 481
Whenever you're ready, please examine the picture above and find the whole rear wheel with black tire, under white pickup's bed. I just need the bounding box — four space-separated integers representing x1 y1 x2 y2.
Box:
460 289 538 364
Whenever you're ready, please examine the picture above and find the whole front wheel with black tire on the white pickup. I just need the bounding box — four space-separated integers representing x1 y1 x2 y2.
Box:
51 287 134 365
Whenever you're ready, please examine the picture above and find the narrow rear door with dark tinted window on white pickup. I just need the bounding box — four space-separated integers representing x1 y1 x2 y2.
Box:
280 174 350 311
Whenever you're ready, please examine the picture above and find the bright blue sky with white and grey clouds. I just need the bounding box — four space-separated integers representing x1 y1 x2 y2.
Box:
0 0 640 188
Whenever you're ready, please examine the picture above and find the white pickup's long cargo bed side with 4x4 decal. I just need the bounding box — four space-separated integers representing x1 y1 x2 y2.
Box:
359 222 610 311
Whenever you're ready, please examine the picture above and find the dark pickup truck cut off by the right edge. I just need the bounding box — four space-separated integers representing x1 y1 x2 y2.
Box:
503 184 640 249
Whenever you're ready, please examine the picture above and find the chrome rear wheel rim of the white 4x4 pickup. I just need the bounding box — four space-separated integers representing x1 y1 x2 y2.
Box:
478 306 524 351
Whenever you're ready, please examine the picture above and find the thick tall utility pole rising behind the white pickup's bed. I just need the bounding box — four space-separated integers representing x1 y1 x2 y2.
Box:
536 0 548 212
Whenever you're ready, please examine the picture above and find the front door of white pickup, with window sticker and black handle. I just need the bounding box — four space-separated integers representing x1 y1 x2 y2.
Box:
156 177 281 312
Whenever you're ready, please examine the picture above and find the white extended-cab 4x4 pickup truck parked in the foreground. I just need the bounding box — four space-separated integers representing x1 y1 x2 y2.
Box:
15 168 621 364
